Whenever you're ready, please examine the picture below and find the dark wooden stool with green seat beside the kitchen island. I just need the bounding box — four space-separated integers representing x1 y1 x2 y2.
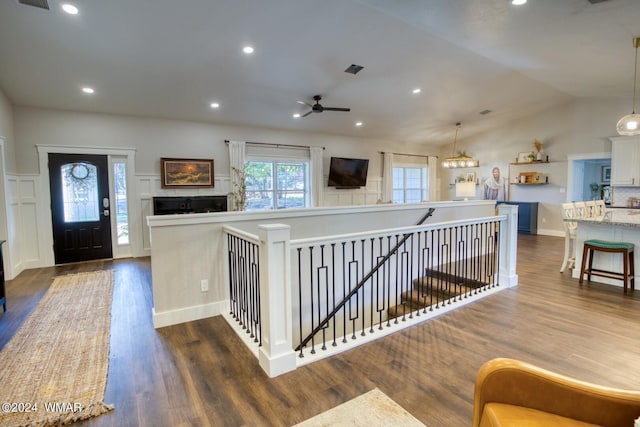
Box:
580 240 635 293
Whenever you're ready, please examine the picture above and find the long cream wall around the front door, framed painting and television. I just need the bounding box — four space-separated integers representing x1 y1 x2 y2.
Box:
13 107 435 268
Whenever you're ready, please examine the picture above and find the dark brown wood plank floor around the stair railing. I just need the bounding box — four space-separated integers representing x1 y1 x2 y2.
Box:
0 236 640 427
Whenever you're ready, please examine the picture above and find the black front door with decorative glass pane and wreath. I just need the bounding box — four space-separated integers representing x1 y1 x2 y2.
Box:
49 153 112 264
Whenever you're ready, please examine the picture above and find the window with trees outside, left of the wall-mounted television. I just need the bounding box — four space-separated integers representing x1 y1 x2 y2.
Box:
244 160 309 211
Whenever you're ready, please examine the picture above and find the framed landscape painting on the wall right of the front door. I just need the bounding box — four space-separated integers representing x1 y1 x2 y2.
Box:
160 158 213 188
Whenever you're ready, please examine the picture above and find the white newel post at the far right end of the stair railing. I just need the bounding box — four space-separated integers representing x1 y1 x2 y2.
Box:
498 204 518 288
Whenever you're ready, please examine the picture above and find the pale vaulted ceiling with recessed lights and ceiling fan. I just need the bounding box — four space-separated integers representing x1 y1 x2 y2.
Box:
0 0 640 144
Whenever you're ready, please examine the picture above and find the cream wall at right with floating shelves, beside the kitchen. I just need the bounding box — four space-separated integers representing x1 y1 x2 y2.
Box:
440 99 629 236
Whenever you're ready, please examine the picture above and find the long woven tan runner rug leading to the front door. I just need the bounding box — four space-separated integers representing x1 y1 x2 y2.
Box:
0 271 113 426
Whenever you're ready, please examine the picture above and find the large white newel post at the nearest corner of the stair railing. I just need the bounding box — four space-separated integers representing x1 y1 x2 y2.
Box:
258 224 296 377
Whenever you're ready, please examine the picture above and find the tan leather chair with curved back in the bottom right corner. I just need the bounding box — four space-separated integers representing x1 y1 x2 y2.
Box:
473 359 640 427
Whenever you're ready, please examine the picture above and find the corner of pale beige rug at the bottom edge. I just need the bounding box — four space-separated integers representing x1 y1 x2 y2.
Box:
296 388 424 427
